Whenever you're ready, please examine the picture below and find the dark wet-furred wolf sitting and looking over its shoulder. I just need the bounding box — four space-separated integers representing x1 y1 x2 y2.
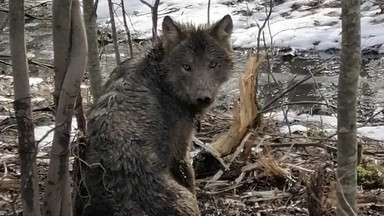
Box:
74 15 233 216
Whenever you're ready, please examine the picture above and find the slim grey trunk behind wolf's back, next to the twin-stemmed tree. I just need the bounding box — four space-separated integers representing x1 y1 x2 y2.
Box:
83 0 102 102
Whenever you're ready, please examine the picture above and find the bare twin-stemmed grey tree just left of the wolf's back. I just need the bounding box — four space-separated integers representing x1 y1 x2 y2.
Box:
43 0 87 216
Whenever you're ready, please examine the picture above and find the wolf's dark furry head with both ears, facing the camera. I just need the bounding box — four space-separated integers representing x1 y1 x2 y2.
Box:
161 15 233 110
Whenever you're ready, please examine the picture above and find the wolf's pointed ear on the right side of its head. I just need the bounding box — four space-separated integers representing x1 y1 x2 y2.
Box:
209 14 233 47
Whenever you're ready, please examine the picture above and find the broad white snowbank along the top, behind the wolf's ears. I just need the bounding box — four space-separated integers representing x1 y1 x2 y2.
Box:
97 0 384 53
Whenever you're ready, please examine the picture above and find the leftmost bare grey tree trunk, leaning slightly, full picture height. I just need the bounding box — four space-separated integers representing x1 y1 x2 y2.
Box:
9 0 40 216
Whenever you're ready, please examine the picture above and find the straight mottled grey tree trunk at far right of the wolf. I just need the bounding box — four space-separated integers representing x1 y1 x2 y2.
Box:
337 0 361 215
